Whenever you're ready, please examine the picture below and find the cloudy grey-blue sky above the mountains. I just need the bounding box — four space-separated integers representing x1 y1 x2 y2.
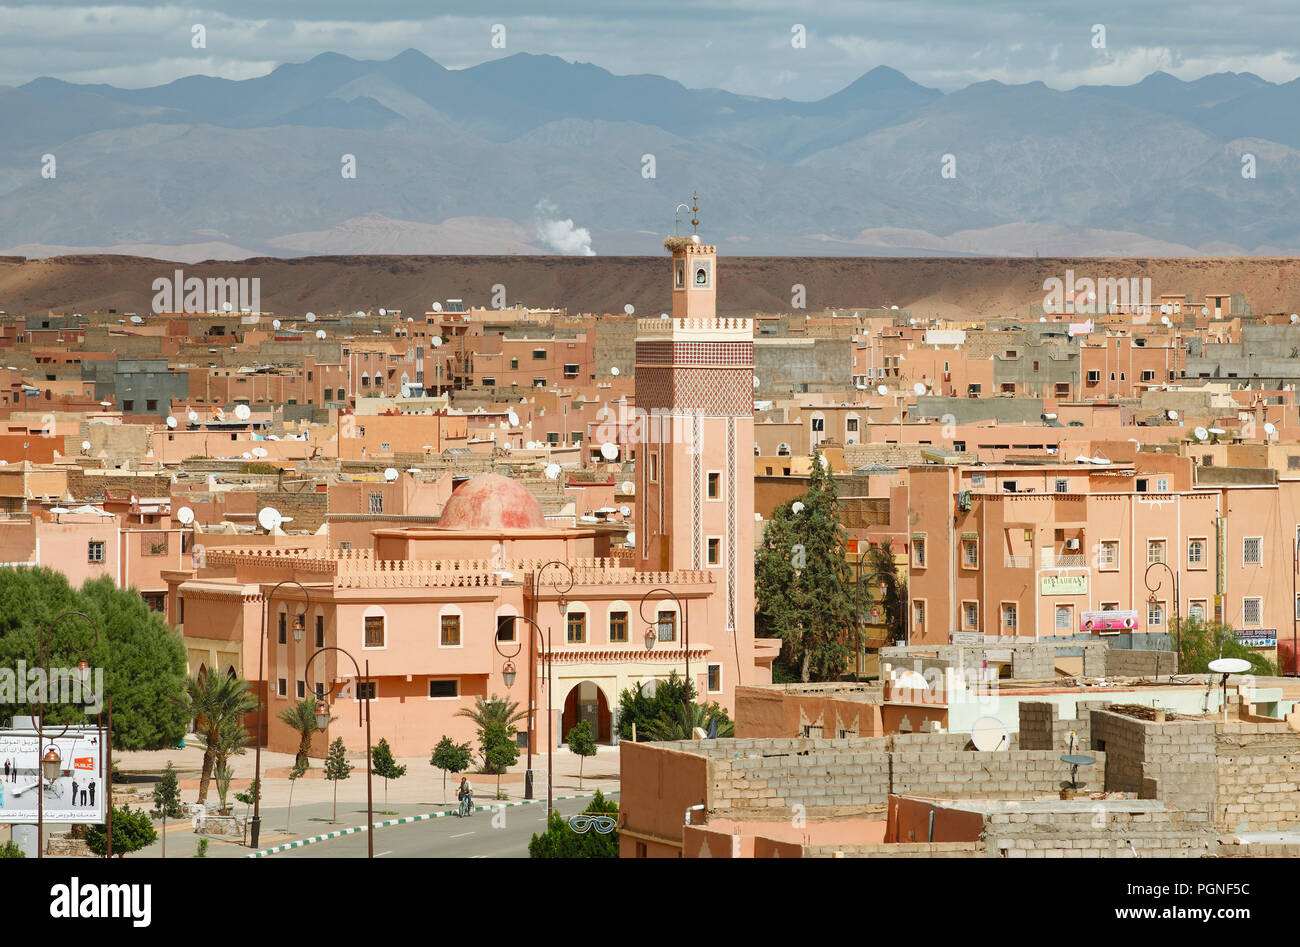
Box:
0 0 1300 100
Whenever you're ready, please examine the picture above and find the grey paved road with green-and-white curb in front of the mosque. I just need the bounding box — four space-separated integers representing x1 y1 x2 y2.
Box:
276 799 592 859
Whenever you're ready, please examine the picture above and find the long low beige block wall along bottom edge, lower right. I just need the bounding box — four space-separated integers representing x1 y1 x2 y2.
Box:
984 809 1217 859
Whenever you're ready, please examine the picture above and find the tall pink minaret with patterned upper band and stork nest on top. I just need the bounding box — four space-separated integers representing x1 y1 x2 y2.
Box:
636 196 754 647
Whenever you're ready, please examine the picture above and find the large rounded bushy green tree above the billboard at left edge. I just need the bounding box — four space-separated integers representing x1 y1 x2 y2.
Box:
0 567 187 749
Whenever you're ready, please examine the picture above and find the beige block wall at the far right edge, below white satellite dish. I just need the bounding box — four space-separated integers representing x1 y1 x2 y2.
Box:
1214 722 1300 831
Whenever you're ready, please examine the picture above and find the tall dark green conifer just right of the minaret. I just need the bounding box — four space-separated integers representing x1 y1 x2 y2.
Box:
754 450 857 682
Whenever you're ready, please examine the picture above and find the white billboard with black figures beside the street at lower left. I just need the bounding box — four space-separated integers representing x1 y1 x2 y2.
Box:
0 727 107 823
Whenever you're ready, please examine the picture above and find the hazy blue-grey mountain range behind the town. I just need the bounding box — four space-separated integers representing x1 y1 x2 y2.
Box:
0 49 1300 261
